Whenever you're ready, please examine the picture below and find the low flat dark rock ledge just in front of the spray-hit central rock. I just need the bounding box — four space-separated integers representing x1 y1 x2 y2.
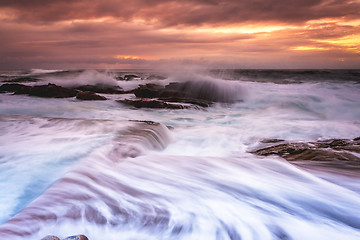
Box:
118 99 191 109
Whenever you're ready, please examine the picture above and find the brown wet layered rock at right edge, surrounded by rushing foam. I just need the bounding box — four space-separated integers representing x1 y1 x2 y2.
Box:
251 138 360 170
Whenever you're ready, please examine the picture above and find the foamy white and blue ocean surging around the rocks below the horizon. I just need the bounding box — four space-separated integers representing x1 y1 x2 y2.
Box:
0 68 360 240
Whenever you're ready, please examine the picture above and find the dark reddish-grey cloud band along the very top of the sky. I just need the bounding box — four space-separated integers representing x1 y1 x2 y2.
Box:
0 0 360 26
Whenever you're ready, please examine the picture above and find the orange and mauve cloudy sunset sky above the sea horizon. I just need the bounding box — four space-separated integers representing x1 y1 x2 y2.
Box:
0 0 360 70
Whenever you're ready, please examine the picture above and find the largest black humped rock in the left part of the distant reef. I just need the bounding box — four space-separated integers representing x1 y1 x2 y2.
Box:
15 83 77 98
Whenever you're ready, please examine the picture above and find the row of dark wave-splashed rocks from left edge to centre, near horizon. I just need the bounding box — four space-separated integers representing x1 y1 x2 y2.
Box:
0 82 228 110
